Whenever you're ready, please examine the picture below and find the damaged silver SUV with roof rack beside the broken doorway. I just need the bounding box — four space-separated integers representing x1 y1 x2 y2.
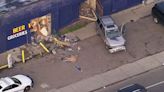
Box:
97 16 126 53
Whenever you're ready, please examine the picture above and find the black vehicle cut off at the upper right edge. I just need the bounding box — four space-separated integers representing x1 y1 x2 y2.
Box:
152 1 164 24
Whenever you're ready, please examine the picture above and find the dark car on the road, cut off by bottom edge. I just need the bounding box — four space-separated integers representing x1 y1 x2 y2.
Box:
117 84 147 92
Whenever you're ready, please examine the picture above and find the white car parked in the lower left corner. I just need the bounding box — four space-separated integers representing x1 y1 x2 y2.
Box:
0 75 33 92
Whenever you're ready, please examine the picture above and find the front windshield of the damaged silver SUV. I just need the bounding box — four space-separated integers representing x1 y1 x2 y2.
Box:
106 30 121 39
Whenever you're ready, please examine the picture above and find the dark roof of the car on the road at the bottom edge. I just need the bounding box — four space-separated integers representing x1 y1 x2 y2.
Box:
118 84 145 92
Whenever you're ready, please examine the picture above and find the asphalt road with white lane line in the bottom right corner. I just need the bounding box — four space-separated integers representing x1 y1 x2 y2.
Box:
94 67 164 92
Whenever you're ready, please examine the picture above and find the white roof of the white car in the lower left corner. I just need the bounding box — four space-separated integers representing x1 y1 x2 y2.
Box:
0 77 14 88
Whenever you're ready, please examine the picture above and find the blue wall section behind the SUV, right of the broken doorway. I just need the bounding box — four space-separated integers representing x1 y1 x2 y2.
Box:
96 0 143 16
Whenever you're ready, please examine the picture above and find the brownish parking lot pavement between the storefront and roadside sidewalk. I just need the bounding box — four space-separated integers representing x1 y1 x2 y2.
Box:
0 16 164 92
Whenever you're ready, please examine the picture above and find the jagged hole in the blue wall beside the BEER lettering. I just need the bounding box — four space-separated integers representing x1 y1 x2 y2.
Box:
29 14 51 40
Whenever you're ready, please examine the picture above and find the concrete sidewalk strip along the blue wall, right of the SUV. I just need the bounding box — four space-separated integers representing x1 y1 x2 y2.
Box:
111 2 155 25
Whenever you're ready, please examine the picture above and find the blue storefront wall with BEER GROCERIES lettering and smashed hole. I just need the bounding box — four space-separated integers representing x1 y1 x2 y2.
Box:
0 0 83 53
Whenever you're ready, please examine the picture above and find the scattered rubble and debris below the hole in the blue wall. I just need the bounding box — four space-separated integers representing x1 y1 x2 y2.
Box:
2 35 81 70
